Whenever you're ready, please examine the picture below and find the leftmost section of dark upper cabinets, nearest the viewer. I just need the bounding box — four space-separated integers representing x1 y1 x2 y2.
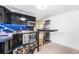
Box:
0 6 11 23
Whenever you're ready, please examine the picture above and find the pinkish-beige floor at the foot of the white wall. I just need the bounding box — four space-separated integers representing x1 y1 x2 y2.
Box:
35 43 79 54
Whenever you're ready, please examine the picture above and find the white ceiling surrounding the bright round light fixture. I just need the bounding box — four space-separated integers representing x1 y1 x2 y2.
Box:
4 5 79 19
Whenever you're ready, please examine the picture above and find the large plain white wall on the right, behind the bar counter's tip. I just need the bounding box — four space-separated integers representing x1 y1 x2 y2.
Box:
49 10 79 49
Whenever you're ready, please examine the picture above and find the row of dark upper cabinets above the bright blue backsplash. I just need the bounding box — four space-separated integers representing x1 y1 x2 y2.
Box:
0 6 36 25
